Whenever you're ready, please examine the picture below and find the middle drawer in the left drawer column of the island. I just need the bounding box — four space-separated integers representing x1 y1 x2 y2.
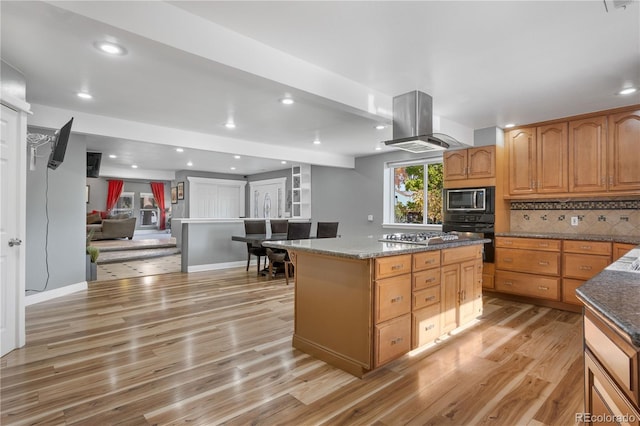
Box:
375 275 411 323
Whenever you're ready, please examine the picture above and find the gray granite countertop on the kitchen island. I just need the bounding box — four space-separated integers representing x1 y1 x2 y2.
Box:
262 236 491 259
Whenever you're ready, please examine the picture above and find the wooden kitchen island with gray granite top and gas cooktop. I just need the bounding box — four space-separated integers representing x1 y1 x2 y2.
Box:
264 237 487 377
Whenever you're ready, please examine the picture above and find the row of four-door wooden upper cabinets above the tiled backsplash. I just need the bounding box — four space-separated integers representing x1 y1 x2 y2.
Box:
505 106 640 199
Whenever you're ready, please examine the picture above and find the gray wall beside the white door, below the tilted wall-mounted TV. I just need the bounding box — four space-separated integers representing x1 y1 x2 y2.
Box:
25 131 87 294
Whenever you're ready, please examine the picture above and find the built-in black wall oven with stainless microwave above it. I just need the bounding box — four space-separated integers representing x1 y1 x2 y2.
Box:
442 186 496 263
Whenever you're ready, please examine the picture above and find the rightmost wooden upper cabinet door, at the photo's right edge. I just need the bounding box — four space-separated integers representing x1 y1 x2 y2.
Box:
608 110 640 191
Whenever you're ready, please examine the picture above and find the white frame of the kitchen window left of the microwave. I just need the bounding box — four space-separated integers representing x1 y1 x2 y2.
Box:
382 156 444 231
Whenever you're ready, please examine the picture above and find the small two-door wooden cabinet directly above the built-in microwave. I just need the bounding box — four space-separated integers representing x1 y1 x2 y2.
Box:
442 145 496 187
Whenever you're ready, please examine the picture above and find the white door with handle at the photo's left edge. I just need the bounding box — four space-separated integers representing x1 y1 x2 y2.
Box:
0 105 26 356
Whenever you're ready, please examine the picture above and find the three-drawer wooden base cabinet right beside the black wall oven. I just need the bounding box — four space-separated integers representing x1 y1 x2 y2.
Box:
495 237 561 301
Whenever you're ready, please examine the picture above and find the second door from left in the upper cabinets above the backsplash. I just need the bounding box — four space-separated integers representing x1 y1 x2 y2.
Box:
536 123 569 194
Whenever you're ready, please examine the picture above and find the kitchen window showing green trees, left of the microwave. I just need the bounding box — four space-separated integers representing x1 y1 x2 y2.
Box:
385 158 443 225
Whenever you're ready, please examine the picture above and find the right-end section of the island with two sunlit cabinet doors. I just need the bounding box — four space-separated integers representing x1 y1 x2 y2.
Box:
440 246 482 333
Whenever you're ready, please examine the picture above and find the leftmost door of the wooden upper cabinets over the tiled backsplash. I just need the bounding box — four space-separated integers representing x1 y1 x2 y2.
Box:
507 128 536 195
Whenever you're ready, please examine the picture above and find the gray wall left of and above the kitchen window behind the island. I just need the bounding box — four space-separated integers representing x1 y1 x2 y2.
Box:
311 151 444 236
